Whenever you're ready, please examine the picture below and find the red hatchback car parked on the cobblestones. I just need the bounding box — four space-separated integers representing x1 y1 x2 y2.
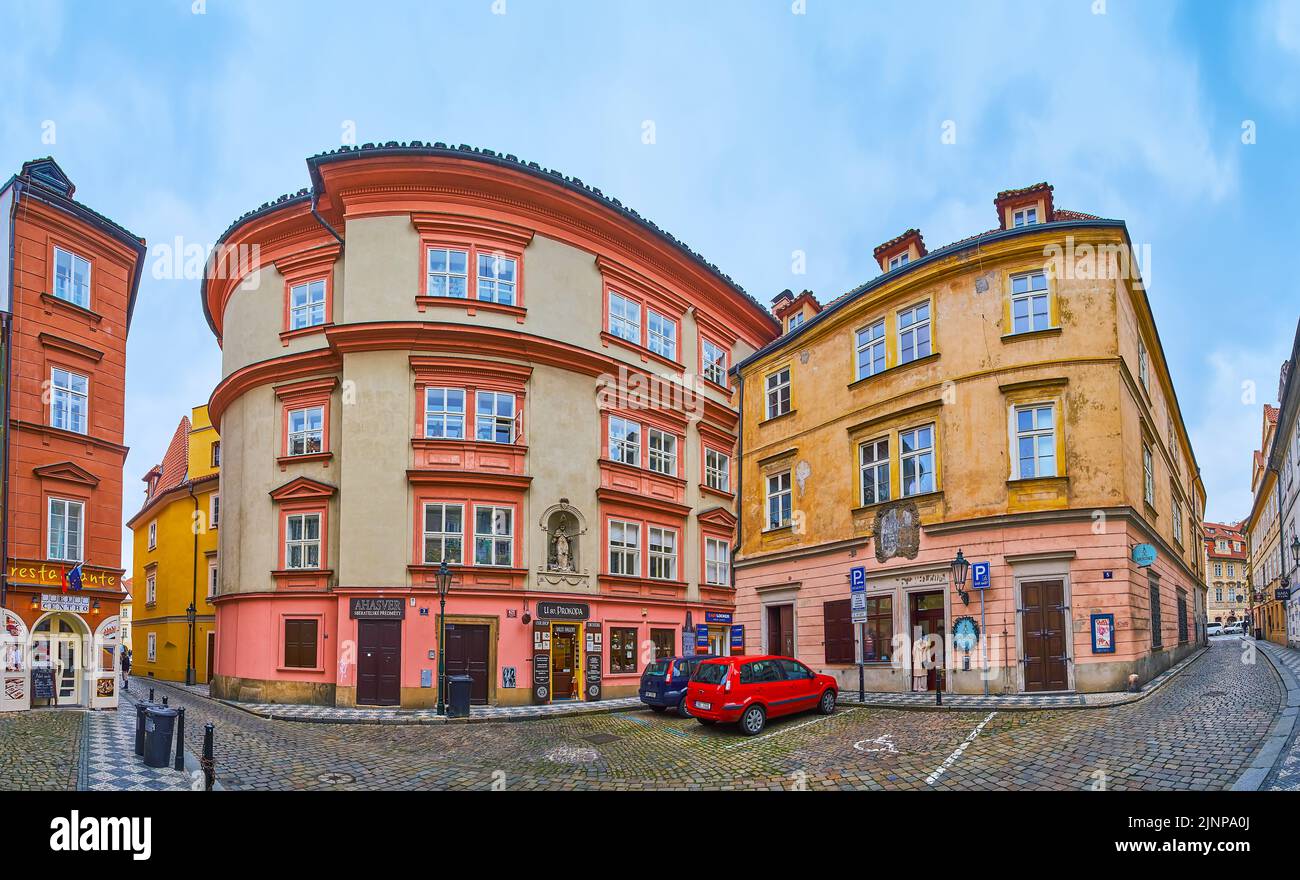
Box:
686 655 840 736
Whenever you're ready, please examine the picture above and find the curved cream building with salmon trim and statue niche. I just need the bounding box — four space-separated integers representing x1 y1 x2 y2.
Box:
203 144 779 707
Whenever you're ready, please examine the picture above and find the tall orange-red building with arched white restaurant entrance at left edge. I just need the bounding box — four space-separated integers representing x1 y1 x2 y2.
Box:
0 159 144 711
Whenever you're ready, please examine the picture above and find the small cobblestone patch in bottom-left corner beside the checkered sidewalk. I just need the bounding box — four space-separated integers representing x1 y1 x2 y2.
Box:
0 708 86 792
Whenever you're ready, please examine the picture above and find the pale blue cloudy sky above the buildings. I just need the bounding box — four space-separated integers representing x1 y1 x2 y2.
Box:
0 0 1300 567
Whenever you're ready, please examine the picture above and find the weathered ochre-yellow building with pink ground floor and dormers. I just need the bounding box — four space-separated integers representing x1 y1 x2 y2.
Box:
736 185 1205 694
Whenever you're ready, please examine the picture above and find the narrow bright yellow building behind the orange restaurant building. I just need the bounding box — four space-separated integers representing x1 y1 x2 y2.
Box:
127 406 221 684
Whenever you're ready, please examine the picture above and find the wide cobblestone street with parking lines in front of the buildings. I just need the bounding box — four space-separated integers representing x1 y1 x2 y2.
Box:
116 642 1281 790
